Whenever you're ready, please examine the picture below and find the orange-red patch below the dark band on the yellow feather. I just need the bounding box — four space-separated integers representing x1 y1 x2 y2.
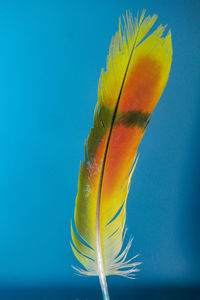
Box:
102 123 144 199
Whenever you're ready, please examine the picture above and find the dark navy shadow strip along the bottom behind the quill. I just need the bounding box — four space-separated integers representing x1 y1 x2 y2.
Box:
0 286 200 300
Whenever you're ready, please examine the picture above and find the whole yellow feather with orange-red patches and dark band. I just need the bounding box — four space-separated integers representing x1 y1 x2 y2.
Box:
71 11 172 300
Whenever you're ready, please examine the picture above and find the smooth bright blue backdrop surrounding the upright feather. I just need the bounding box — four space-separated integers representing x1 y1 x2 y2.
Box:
0 0 200 299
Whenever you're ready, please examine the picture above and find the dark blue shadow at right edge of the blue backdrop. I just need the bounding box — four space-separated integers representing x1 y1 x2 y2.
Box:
182 103 200 282
